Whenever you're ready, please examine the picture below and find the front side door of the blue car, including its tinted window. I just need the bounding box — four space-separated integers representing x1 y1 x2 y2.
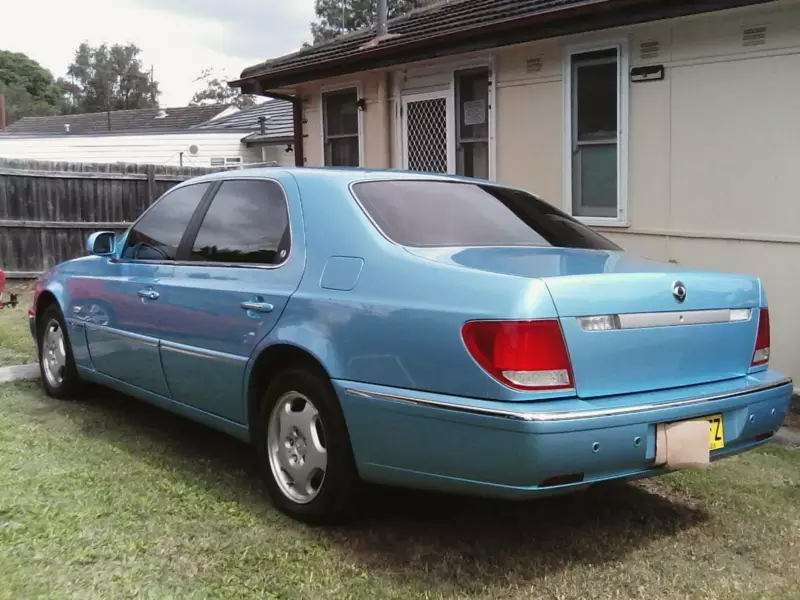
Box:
82 183 210 397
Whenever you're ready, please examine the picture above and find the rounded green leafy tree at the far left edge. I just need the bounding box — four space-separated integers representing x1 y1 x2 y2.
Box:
0 50 65 123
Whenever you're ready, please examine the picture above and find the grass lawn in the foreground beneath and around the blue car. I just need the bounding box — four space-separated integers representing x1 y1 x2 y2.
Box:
0 384 800 600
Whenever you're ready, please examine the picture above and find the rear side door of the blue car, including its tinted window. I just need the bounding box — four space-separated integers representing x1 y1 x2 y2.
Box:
152 178 305 423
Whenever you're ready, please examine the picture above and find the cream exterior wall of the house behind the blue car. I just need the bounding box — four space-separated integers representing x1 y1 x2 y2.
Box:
292 0 800 378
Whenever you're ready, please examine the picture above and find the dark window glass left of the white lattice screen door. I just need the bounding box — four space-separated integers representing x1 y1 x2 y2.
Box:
322 89 360 167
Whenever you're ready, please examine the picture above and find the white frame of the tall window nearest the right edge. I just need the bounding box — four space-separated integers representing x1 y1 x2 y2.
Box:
562 39 630 227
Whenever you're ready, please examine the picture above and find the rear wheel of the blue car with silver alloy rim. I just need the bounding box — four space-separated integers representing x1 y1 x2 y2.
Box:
254 368 359 525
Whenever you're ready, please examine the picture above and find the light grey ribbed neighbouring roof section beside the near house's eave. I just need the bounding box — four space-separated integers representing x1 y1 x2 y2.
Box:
192 100 294 144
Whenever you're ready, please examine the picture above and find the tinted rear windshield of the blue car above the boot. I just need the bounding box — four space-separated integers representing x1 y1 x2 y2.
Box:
353 180 620 250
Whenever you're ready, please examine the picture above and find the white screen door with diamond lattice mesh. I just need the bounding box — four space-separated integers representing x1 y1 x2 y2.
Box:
403 92 455 173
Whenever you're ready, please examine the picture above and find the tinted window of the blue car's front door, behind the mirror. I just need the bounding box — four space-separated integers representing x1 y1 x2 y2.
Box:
122 183 211 260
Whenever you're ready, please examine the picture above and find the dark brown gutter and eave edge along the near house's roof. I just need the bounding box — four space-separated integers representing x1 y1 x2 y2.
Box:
229 0 774 93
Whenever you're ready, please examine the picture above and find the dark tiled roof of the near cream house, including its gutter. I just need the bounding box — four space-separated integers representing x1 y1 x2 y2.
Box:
230 0 773 93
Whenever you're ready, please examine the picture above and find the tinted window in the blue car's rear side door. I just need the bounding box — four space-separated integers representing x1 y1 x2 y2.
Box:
191 180 289 265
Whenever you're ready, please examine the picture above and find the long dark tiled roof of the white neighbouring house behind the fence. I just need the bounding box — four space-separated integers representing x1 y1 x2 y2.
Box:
6 105 230 135
